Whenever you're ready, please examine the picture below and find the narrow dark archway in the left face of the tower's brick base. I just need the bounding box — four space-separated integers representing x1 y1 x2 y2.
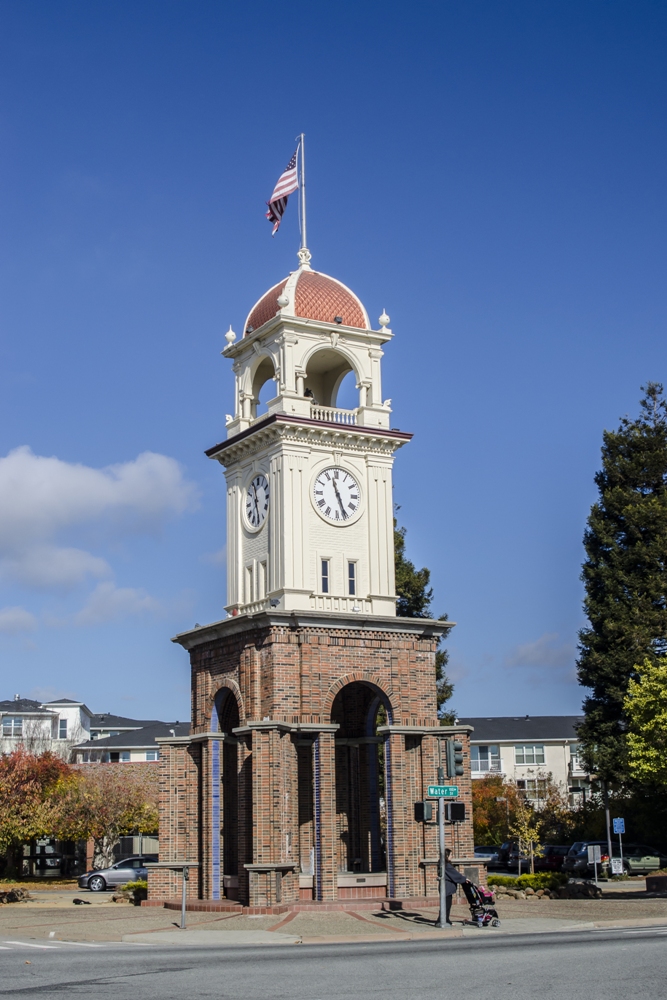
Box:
215 687 239 895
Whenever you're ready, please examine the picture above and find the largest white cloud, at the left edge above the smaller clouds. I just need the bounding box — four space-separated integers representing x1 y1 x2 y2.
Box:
0 446 196 590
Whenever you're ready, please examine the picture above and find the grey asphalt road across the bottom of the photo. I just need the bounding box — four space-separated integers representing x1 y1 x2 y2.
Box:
0 926 667 1000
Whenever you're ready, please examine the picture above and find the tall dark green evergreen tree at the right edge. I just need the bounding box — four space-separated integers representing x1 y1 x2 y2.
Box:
578 382 667 783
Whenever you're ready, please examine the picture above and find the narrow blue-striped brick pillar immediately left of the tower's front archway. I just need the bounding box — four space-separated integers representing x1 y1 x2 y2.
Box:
313 732 338 900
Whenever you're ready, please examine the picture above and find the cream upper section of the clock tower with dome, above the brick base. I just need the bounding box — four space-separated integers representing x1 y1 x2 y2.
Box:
207 252 411 616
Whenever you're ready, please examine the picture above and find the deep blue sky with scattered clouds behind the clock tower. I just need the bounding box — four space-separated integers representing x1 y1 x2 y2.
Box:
0 0 667 719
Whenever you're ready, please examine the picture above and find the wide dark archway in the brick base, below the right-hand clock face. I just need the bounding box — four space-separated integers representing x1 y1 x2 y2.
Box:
331 681 392 873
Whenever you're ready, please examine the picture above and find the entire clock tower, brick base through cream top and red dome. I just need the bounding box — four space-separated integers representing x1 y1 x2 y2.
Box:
149 248 474 912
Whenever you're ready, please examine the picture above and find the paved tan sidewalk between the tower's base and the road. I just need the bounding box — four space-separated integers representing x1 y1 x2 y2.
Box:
0 883 667 945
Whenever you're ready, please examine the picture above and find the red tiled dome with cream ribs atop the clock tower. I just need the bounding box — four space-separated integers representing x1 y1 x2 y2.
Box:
243 268 370 336
